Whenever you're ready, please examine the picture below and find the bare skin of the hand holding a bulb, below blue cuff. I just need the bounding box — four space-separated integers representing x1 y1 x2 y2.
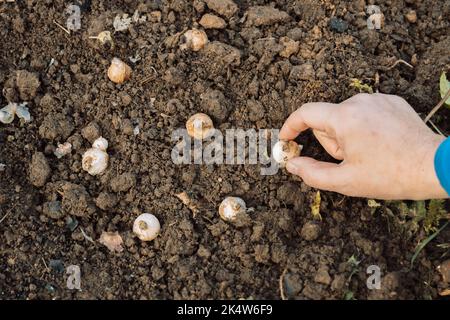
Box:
279 93 448 200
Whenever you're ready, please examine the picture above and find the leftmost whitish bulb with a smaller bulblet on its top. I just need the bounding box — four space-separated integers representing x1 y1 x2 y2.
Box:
81 137 109 176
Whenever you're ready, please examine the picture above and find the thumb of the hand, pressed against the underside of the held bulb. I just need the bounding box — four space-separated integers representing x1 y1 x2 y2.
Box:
286 157 352 193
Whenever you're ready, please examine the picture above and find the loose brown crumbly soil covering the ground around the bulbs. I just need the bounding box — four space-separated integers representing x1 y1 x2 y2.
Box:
0 0 450 299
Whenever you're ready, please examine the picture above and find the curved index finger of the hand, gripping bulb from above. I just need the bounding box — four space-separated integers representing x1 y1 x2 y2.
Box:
279 102 336 140
